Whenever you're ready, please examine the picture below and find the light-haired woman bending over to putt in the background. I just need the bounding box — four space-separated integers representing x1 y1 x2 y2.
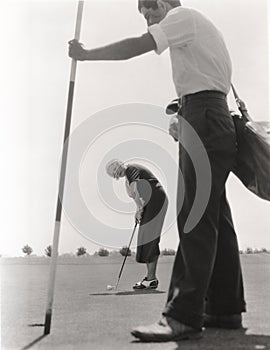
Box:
106 159 168 289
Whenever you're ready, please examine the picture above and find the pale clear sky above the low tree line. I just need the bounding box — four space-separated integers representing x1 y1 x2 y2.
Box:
0 0 270 256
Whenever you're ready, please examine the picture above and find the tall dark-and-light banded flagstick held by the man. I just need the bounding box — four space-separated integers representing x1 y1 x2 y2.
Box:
44 0 84 335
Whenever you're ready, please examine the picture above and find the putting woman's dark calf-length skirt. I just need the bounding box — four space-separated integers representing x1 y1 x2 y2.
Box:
136 187 168 263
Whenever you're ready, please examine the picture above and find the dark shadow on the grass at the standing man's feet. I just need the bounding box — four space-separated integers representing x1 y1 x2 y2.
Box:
132 329 270 350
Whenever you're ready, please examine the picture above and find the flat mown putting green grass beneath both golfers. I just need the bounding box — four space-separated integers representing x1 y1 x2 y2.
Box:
1 254 270 350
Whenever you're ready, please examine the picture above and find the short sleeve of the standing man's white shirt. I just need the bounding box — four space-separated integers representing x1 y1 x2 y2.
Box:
148 6 195 55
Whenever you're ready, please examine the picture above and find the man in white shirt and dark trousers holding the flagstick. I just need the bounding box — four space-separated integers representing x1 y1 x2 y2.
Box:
69 0 245 341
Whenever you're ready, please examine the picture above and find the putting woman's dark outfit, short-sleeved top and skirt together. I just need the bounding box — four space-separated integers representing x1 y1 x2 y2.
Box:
126 164 168 263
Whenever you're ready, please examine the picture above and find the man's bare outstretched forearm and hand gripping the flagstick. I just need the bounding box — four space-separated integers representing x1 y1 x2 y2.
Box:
69 33 156 61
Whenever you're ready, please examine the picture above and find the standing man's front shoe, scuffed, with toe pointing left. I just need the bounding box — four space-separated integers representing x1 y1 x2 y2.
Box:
131 317 202 342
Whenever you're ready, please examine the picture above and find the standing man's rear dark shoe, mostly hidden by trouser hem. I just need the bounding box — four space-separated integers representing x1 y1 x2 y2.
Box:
203 314 242 329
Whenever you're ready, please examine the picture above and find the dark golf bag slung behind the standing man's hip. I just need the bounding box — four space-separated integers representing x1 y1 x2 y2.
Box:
166 85 270 200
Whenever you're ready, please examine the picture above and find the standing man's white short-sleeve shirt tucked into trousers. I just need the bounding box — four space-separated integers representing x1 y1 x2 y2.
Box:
148 6 232 97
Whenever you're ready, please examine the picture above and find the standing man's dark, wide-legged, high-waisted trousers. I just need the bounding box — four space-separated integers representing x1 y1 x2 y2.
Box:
163 91 245 328
